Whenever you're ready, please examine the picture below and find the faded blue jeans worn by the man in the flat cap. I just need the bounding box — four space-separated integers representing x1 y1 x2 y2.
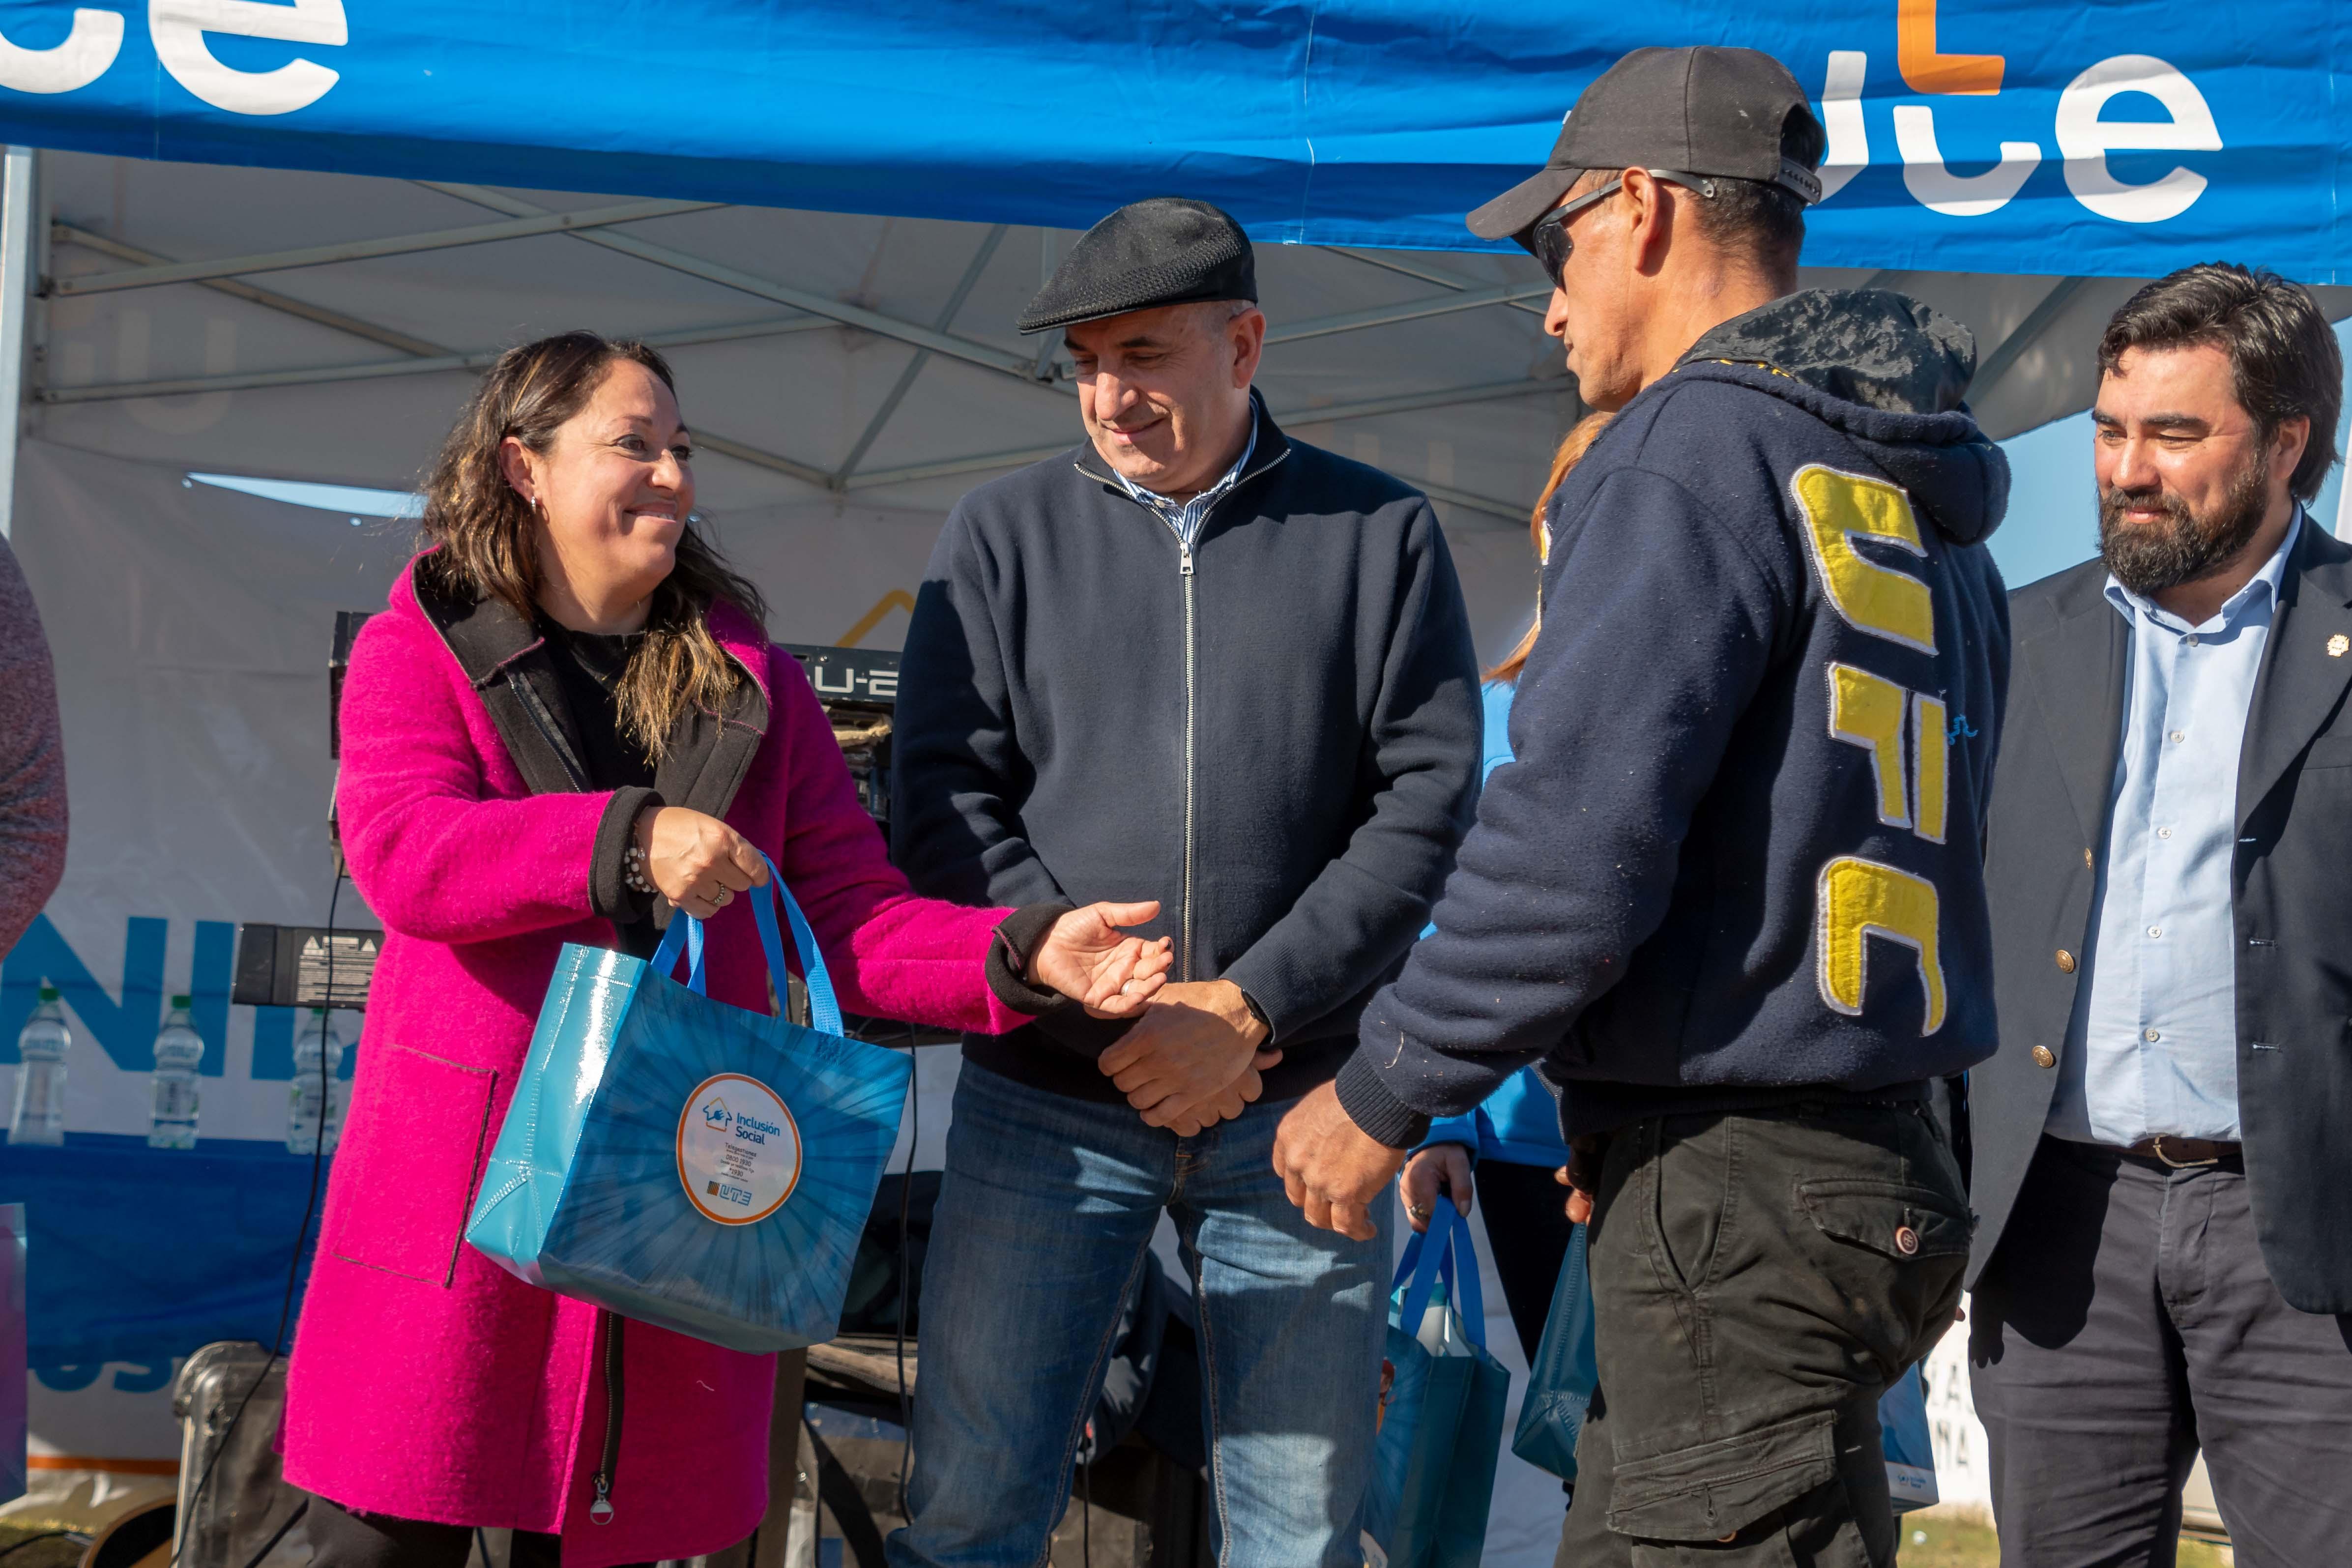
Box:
889 1065 1390 1568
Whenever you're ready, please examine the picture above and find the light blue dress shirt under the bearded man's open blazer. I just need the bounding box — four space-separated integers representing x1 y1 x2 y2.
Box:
2046 508 2303 1145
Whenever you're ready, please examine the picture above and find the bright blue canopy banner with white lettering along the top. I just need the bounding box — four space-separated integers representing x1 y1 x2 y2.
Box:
0 0 2352 282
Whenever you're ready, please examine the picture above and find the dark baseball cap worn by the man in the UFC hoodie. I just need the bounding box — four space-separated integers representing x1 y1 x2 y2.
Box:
1470 45 1823 244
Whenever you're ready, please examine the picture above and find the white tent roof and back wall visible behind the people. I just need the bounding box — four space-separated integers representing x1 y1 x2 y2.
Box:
0 148 2352 1563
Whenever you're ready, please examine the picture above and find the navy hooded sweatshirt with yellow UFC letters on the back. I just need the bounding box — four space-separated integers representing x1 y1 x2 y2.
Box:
1338 291 2008 1147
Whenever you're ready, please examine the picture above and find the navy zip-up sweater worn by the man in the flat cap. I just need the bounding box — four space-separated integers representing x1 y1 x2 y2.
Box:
892 395 1480 1103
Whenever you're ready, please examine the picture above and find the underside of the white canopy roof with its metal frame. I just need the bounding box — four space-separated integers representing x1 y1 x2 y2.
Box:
0 153 2295 571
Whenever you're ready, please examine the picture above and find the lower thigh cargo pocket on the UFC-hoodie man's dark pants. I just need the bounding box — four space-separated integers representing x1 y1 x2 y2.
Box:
1609 1411 1865 1568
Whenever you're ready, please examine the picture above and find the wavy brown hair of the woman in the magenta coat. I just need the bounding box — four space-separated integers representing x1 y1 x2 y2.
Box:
416 331 767 762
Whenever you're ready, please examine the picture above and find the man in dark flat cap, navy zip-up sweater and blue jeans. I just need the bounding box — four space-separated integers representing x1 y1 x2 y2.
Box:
889 198 1480 1568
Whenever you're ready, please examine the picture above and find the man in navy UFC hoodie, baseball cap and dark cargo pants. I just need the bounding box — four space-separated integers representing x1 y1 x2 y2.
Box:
1275 49 2008 1568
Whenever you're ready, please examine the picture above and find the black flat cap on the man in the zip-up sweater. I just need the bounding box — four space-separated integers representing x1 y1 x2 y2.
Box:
1021 195 1258 334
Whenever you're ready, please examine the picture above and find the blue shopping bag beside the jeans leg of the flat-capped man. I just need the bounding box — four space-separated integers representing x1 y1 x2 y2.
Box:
1364 1204 1510 1568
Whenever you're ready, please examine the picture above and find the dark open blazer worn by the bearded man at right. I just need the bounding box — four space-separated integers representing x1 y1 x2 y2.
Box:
1969 517 2352 1312
